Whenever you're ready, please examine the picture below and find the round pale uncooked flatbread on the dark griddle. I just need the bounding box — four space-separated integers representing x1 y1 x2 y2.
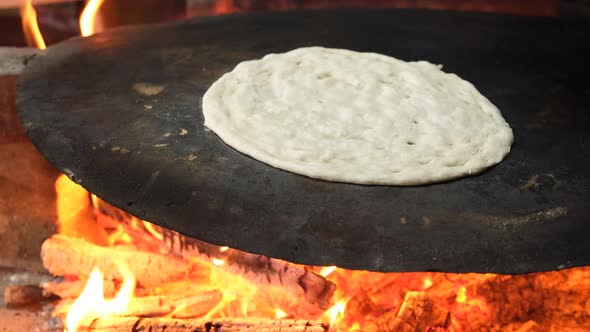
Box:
203 47 513 185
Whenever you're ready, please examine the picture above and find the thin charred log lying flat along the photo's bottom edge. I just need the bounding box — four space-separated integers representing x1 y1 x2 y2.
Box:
87 317 328 332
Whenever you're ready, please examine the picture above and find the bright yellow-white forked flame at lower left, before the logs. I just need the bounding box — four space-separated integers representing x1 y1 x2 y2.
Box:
66 263 135 332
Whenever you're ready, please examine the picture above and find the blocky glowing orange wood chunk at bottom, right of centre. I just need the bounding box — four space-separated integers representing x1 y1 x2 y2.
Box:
377 291 451 332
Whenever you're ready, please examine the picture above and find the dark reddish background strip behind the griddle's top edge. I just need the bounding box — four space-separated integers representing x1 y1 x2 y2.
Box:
0 0 590 46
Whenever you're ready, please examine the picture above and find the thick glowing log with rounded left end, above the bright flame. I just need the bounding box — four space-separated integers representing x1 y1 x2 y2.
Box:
41 235 194 288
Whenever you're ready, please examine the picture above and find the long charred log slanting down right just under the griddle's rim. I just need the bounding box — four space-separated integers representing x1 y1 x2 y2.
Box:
93 198 336 316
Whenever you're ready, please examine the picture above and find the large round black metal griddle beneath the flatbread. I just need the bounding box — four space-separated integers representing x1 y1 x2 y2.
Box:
18 10 590 273
